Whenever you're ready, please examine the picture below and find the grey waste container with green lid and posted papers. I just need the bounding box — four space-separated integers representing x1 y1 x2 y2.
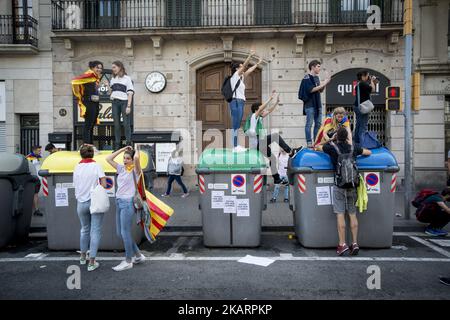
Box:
196 149 266 247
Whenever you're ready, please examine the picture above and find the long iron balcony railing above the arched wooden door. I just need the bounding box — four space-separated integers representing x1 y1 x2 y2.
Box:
52 0 403 30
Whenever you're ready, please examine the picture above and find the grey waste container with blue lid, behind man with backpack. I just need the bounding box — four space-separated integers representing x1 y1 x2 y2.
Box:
288 148 399 248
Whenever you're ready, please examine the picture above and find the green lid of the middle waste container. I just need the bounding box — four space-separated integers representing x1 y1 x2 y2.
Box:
197 149 266 173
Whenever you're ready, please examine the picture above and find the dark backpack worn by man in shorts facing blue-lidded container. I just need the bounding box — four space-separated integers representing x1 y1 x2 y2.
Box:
331 142 359 189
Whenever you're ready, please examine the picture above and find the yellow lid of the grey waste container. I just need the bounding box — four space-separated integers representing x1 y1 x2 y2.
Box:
39 150 148 176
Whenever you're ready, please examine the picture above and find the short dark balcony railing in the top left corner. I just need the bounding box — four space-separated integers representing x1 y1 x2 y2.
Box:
0 15 38 47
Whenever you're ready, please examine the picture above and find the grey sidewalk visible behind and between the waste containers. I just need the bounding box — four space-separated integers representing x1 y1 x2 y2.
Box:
31 189 436 232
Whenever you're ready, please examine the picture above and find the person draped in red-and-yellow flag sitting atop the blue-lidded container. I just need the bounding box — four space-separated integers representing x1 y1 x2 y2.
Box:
314 107 352 150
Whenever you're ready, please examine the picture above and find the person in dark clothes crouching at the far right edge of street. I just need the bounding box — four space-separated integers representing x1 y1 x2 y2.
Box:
415 188 450 236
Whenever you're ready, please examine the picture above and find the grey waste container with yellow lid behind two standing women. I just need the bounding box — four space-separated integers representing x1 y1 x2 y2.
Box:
39 151 147 250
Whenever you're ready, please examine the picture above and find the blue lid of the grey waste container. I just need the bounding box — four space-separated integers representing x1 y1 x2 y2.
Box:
290 147 398 171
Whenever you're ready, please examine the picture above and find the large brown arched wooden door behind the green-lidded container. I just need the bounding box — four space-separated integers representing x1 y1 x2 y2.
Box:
196 63 261 150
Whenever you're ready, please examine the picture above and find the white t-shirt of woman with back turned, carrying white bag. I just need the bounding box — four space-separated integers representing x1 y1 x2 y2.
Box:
73 162 105 202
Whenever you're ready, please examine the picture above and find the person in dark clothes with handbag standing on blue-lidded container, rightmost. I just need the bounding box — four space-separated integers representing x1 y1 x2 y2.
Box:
353 70 378 144
